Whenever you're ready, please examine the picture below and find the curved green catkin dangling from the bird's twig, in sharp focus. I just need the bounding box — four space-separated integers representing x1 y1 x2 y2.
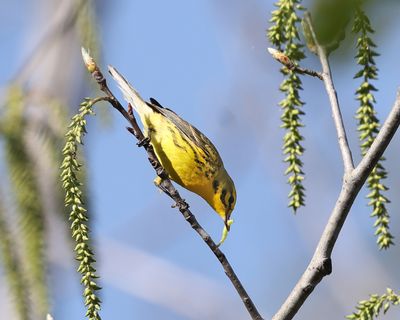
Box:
61 99 101 320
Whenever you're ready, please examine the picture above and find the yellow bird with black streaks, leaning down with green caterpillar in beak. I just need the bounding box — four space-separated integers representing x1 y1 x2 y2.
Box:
108 66 236 244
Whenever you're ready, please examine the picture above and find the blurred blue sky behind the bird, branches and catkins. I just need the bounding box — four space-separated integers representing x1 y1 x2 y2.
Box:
0 0 400 320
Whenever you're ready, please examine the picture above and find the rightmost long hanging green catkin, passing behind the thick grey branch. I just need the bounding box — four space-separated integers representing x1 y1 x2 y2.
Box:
352 1 393 249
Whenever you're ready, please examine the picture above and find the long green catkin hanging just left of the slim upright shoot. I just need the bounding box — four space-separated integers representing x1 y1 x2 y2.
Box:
267 0 305 212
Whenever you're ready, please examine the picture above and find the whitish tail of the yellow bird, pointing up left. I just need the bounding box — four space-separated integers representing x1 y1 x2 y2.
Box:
108 66 152 120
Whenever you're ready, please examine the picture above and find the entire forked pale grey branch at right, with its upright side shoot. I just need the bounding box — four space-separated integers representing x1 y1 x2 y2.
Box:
272 15 400 320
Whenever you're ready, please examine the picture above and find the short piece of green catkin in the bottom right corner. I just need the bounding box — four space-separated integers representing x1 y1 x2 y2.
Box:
346 288 400 320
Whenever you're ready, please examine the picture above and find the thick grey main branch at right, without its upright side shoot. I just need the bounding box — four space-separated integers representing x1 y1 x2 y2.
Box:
272 91 400 320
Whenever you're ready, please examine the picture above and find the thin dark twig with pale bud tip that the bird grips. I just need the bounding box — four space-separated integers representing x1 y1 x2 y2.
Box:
83 49 263 320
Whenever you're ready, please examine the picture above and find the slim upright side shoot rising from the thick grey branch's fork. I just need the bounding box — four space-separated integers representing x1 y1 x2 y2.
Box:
304 13 354 174
